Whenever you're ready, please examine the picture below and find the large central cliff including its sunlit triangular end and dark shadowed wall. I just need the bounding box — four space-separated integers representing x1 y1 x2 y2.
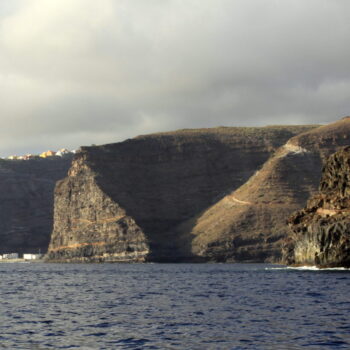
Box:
47 126 312 261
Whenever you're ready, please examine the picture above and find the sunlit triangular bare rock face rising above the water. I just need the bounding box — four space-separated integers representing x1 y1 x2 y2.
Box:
50 161 149 262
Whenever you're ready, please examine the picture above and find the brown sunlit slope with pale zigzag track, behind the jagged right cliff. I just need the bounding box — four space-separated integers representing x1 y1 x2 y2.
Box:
190 118 350 262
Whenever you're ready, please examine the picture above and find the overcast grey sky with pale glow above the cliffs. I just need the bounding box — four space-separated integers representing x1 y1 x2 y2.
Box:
0 0 350 157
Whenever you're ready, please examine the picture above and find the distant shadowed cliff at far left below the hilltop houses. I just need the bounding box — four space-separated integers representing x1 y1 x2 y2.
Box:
0 155 72 254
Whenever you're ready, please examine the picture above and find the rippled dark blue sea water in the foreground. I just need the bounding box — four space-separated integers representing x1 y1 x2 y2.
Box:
0 263 350 350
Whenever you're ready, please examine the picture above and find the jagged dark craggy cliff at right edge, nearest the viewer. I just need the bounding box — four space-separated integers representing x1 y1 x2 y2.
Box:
284 147 350 267
